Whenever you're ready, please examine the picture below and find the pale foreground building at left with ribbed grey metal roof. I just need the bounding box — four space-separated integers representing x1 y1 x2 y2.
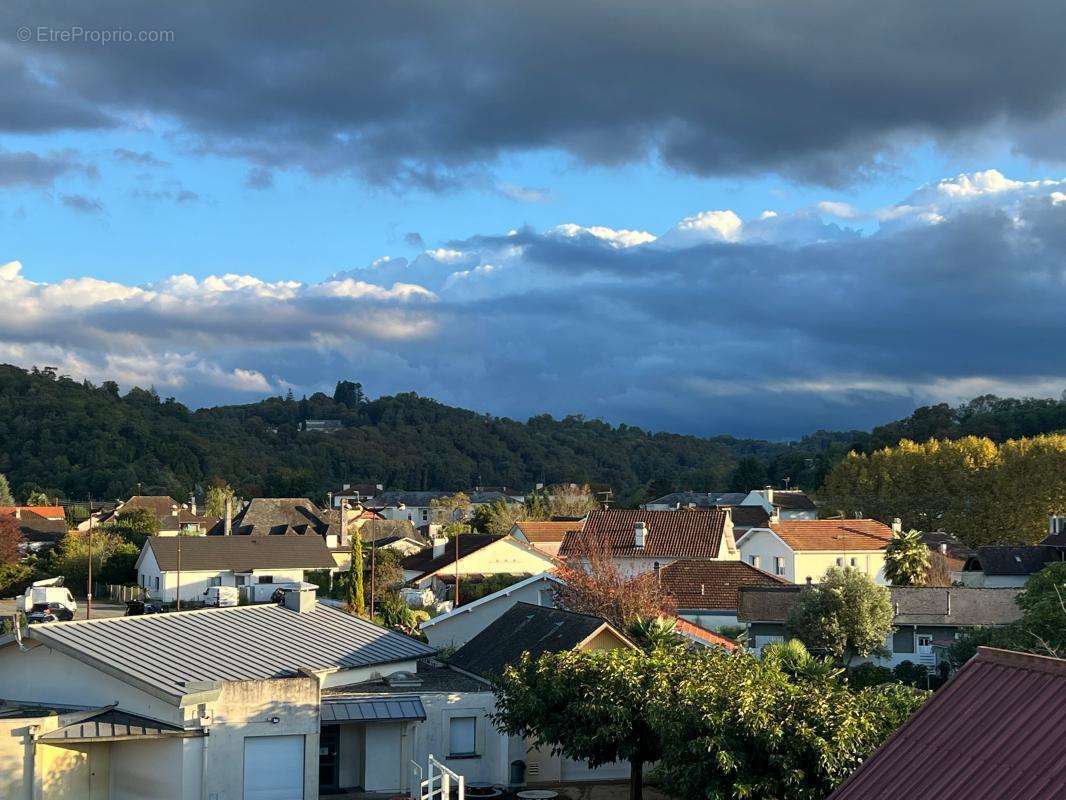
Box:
0 591 433 800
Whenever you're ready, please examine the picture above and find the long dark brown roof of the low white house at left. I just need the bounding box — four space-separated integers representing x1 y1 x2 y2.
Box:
144 537 337 572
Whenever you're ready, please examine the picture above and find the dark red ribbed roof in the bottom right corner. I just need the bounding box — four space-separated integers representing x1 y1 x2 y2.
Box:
829 647 1066 800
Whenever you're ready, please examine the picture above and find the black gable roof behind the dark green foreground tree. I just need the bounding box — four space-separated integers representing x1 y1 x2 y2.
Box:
448 603 634 677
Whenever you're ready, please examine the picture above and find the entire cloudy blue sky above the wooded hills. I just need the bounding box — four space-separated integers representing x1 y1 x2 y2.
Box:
0 0 1066 438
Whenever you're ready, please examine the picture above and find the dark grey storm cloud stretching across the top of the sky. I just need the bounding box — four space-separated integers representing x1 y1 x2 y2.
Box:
6 0 1066 189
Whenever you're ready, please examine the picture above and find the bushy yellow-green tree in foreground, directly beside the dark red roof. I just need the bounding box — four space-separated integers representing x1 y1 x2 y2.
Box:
650 650 926 800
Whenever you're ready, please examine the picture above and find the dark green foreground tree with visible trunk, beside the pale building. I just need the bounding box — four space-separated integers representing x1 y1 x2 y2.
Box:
492 649 677 800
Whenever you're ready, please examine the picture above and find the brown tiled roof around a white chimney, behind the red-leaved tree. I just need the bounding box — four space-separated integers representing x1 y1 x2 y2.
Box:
559 509 727 558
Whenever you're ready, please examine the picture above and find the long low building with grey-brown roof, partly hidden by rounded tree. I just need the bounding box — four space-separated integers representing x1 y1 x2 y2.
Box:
738 586 1021 667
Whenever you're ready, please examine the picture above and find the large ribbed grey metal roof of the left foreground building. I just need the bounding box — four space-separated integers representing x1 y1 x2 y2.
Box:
28 603 436 698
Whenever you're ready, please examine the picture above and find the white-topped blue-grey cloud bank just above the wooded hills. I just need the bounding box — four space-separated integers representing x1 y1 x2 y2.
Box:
8 171 1066 437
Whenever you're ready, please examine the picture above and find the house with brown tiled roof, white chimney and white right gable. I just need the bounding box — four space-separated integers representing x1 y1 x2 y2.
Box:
559 508 740 576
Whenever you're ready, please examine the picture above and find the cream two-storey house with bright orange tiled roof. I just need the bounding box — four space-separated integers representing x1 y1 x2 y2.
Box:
738 519 893 583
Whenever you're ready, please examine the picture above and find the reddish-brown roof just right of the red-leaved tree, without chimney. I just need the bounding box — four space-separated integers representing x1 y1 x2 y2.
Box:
659 559 791 610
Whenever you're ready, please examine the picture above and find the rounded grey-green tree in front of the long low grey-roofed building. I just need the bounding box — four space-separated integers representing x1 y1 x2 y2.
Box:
788 567 892 666
